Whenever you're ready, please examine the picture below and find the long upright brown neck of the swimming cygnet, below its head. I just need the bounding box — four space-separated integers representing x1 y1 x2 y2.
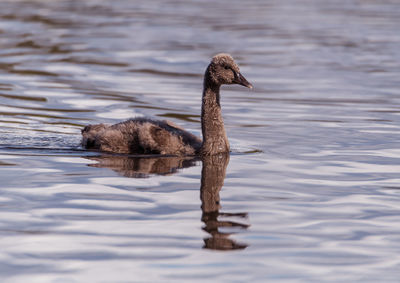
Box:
201 70 229 155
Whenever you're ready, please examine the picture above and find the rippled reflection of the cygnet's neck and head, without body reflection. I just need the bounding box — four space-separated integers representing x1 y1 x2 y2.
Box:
200 154 249 250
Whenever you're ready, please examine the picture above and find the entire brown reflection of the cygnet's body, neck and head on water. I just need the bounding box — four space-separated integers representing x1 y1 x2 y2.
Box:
86 153 249 250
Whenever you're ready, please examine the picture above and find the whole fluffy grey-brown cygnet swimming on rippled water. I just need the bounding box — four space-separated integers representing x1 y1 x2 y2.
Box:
82 53 252 156
